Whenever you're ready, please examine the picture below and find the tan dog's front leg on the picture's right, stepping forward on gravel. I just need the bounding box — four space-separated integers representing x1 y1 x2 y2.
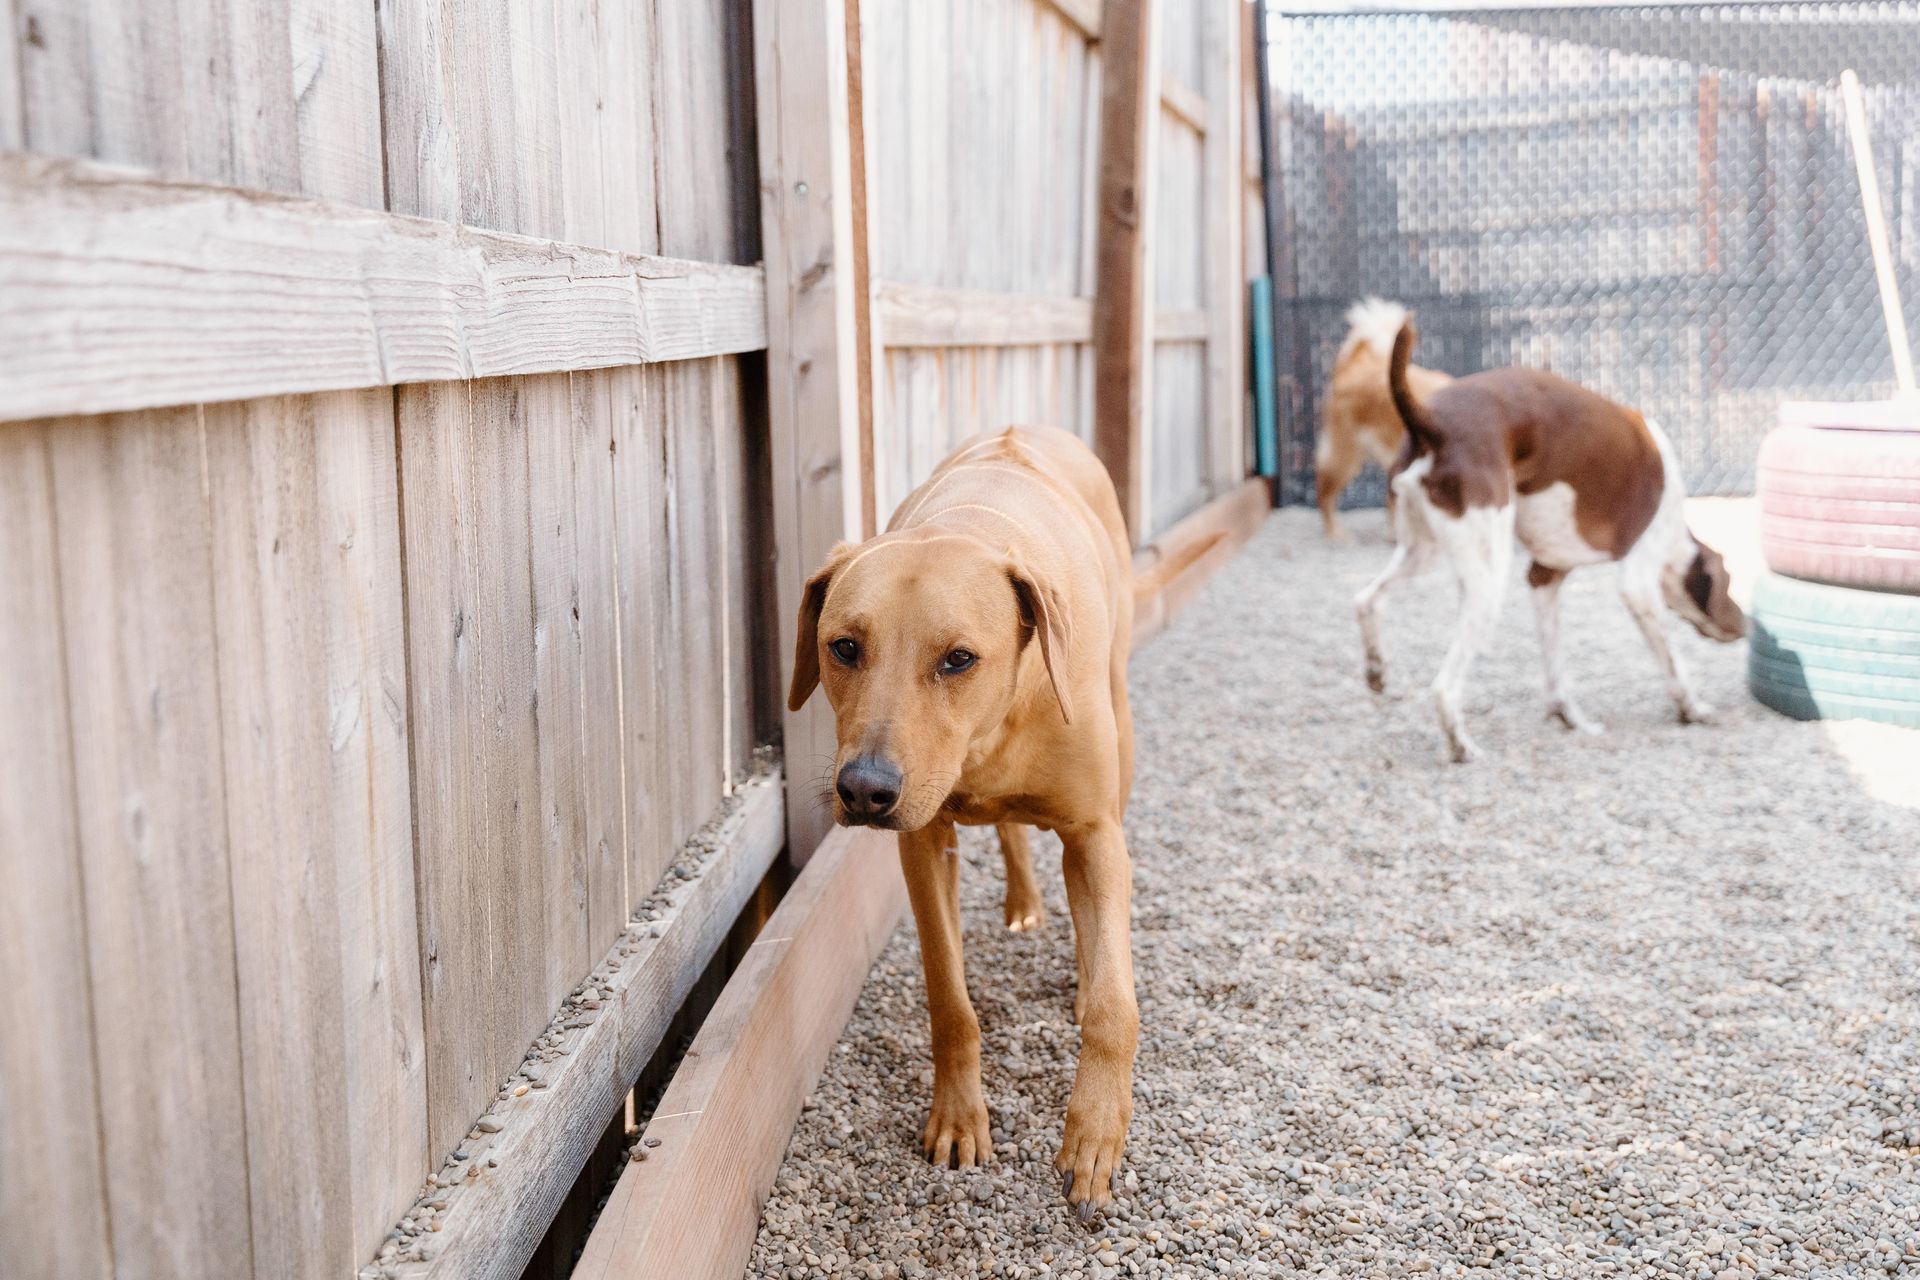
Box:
1054 821 1140 1222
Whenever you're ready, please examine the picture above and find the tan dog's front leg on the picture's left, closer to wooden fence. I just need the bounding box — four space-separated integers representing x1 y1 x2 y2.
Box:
900 821 993 1169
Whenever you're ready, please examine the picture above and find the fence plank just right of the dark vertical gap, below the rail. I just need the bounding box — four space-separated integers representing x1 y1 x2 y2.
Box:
396 382 557 1161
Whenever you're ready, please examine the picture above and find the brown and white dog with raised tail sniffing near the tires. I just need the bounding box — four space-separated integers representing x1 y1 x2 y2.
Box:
1354 322 1747 762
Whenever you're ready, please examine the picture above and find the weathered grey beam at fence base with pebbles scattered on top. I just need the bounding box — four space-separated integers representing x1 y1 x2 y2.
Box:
363 771 791 1280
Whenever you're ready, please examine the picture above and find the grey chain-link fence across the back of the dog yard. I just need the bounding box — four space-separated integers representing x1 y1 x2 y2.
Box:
1267 0 1920 505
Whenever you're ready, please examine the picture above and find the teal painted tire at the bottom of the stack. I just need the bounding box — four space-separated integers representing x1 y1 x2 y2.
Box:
1747 574 1920 729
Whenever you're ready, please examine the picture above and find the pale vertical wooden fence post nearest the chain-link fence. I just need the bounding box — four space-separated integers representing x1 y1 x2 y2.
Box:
1200 0 1252 493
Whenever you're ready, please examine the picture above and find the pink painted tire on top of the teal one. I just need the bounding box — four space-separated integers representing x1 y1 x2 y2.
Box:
1759 426 1920 593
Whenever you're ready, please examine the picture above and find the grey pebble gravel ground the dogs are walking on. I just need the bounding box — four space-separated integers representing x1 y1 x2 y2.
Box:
751 512 1920 1280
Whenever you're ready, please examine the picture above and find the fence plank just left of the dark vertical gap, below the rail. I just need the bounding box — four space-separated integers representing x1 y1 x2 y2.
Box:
204 391 426 1276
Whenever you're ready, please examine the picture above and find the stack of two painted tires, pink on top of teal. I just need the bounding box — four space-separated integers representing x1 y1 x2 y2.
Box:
1747 405 1920 727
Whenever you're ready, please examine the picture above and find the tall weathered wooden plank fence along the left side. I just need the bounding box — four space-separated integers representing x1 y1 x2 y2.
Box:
0 0 1246 1280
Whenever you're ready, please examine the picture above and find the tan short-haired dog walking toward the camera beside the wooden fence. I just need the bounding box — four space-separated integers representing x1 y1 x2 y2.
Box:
787 428 1190 1221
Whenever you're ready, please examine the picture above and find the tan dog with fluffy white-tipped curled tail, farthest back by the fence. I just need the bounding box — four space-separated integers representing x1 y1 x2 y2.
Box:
1313 297 1452 541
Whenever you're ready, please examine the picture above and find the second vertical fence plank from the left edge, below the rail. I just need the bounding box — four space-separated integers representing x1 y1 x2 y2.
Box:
50 409 252 1276
